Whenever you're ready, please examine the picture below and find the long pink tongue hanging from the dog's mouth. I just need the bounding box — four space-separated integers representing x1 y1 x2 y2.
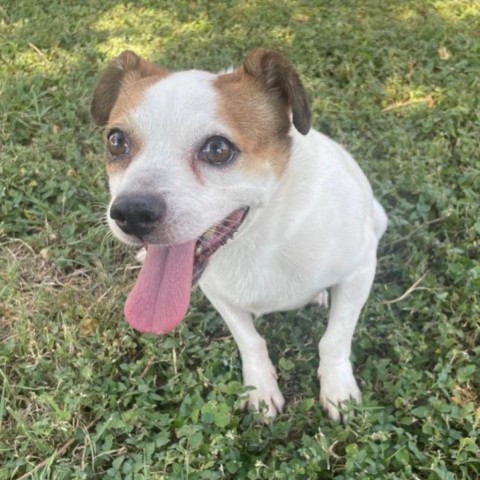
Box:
124 240 195 334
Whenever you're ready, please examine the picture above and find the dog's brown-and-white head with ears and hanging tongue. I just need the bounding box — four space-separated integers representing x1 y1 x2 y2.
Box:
91 49 310 333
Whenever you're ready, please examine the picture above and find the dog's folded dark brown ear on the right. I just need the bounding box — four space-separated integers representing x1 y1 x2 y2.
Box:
243 48 312 135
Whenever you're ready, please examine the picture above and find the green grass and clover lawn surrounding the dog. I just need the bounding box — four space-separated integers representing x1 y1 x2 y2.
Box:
0 0 480 480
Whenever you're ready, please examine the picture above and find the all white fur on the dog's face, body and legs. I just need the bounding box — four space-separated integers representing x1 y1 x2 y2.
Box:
110 71 387 419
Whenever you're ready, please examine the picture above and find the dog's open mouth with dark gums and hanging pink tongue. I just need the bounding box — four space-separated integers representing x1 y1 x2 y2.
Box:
124 208 248 334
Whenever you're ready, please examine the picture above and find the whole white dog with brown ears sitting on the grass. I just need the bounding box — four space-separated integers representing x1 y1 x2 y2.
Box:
90 48 387 420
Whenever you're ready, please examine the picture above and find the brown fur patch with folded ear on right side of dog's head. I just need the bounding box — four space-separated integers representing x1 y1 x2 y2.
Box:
215 49 311 176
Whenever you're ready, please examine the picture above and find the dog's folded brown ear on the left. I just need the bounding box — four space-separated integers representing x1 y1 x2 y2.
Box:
90 50 168 126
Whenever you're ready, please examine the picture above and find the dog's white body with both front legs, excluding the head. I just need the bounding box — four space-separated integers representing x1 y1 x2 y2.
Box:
200 130 387 419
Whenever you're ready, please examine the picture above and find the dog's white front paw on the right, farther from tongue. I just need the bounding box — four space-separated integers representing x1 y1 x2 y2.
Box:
318 362 361 421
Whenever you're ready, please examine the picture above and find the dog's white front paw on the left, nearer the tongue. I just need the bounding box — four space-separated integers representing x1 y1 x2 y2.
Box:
241 365 285 418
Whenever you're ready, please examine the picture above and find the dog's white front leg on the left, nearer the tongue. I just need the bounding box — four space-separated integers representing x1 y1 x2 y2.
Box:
205 292 285 417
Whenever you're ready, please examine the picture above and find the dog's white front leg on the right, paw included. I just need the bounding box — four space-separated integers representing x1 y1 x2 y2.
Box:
318 254 376 420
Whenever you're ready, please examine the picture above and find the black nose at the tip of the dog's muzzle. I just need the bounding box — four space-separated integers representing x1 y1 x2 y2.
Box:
110 195 167 238
